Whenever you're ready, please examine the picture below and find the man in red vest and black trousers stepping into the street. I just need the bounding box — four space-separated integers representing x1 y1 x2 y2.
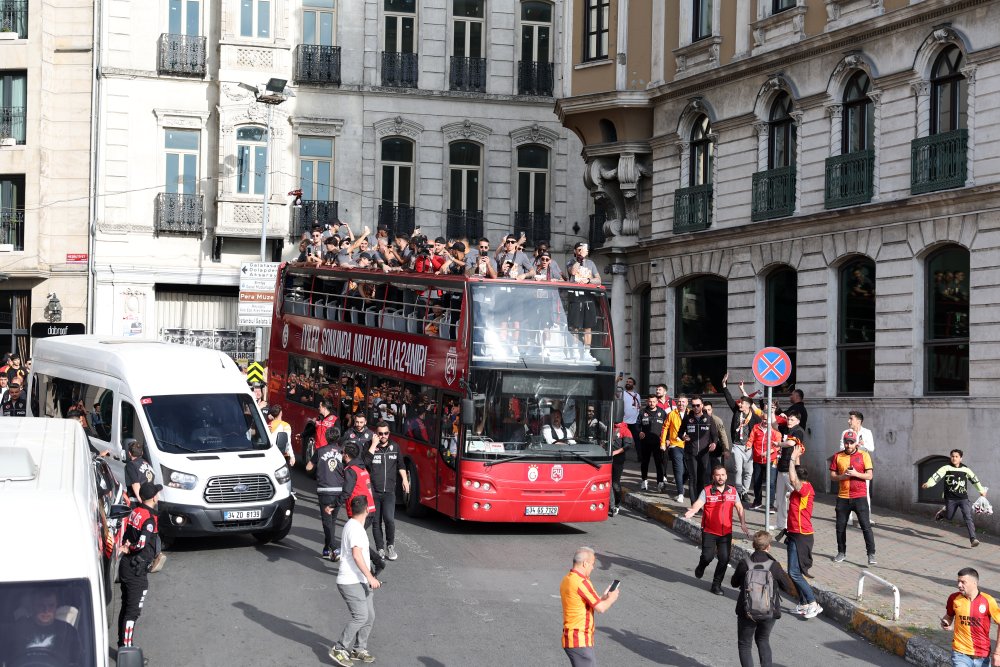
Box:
684 465 750 595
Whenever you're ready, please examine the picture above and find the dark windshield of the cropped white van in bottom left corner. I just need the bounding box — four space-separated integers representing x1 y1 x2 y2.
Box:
0 579 96 667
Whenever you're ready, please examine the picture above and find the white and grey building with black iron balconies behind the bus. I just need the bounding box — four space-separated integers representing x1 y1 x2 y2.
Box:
95 0 588 350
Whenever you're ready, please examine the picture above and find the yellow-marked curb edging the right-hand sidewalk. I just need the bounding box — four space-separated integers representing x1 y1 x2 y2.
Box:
623 490 951 667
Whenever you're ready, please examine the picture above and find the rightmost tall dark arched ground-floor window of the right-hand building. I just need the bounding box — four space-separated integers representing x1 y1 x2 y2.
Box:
924 246 969 394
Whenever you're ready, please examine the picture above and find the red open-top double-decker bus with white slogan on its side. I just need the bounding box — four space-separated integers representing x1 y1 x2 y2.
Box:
268 264 614 522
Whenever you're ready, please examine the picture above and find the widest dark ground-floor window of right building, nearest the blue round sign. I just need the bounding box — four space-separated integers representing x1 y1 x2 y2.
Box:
674 276 729 394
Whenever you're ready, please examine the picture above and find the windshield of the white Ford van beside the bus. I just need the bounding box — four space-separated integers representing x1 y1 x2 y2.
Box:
140 394 271 454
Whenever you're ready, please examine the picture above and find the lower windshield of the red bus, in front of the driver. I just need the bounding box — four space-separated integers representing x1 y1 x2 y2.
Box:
465 370 613 460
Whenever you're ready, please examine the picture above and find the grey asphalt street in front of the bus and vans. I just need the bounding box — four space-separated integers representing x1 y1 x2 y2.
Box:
121 473 906 667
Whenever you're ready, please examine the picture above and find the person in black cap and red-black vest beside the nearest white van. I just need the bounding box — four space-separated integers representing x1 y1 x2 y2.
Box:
118 482 163 647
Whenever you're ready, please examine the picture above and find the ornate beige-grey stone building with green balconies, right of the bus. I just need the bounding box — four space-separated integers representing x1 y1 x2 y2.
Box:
557 0 1000 528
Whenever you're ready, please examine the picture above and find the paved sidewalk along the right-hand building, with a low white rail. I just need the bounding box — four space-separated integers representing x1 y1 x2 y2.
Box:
623 468 1000 667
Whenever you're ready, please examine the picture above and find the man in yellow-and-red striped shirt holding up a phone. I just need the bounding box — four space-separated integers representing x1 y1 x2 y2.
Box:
559 547 618 667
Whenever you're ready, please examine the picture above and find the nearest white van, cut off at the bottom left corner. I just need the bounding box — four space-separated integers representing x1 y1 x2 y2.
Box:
0 417 142 667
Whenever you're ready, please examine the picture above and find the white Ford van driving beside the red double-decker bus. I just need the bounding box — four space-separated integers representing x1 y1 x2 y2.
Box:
28 336 295 544
